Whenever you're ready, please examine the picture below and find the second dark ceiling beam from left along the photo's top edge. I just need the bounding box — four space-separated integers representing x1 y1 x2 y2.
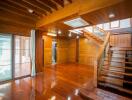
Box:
23 0 52 13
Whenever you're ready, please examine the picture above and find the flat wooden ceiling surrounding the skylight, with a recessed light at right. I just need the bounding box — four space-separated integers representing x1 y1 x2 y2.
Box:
40 0 132 36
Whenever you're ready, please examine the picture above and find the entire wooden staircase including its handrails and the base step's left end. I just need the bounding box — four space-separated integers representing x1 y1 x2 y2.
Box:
80 27 132 100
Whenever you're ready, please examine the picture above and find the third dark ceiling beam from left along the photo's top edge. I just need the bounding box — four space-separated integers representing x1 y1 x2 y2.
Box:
37 0 58 10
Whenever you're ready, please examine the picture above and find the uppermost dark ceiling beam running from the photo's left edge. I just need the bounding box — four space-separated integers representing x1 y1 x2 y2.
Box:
0 2 36 21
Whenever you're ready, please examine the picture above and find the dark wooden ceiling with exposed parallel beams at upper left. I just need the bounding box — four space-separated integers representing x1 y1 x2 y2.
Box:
0 0 72 32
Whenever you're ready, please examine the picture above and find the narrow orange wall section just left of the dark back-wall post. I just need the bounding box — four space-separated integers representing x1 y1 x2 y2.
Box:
68 39 78 63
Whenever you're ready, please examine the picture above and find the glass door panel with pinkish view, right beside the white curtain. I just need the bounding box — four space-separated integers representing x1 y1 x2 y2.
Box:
14 36 31 78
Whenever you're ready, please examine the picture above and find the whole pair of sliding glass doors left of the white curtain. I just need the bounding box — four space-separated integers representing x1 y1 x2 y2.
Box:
0 34 31 82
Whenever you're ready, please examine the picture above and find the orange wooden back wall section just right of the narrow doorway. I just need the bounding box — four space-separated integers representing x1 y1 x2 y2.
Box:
57 39 68 64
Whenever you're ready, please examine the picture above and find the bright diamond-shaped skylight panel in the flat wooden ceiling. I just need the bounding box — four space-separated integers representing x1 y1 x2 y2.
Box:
64 18 89 28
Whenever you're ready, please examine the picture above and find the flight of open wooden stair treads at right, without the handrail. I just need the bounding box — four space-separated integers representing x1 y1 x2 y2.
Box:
98 47 132 97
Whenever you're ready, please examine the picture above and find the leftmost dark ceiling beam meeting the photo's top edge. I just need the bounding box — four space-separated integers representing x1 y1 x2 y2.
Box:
8 0 47 15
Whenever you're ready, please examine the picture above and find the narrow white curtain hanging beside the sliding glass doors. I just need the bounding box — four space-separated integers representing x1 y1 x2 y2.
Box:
30 30 36 76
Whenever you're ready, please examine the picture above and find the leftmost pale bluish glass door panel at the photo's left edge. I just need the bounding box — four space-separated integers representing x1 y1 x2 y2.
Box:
0 34 12 82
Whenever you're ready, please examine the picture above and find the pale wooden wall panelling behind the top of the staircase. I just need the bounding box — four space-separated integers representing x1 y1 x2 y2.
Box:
110 34 132 47
